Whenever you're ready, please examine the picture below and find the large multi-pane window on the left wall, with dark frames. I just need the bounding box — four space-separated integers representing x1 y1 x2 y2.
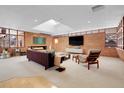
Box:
0 28 24 48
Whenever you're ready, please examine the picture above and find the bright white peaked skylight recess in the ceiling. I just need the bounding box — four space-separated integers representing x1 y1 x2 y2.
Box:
33 19 73 35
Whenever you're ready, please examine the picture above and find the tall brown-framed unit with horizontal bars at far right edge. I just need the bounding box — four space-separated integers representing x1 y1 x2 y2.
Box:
117 17 124 50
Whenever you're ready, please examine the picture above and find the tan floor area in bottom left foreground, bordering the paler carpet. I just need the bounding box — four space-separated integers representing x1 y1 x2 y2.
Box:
0 76 57 88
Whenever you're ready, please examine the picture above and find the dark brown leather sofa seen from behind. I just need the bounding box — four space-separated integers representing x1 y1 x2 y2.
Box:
27 50 54 70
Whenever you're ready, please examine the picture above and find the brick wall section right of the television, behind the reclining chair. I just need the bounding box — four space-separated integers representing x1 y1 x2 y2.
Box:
83 32 118 57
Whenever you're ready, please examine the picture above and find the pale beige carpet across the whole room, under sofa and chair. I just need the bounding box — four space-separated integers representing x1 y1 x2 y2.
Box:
0 56 124 88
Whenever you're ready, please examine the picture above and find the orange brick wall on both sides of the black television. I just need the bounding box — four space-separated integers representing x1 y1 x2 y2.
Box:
54 32 118 57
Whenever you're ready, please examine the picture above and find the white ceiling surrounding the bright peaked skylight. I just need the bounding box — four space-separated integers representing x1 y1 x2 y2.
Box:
0 5 124 35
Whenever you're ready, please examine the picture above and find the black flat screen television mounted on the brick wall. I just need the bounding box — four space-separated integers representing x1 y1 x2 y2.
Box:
69 36 84 46
